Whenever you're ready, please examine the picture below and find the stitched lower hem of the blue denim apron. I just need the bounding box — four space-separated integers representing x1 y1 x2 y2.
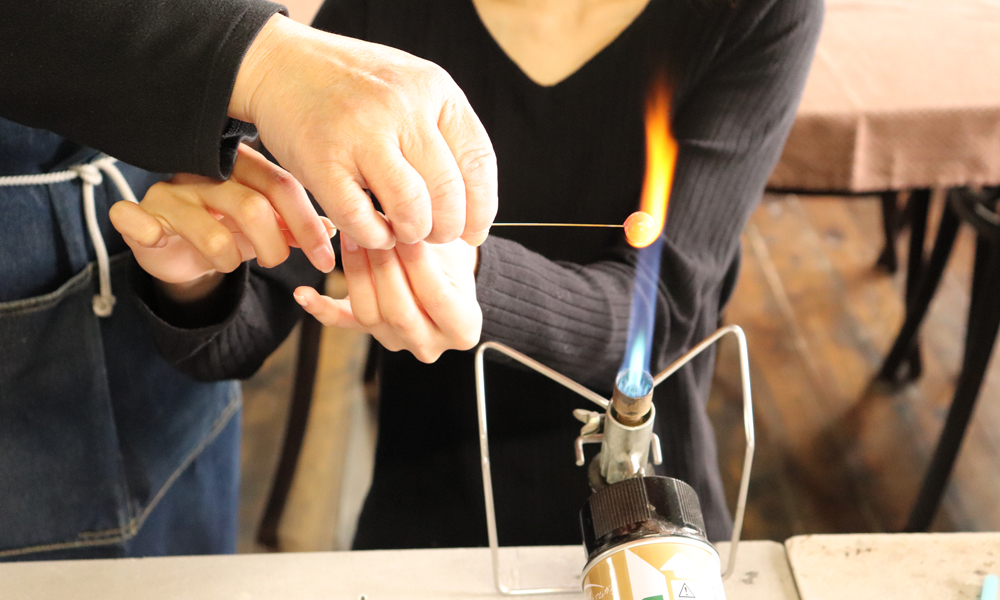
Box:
0 385 243 558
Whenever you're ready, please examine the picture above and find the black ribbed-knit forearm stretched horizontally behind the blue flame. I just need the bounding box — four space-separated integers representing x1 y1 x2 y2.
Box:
476 237 720 389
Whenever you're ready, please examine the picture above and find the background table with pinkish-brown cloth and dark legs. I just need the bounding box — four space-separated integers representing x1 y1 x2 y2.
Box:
768 0 1000 531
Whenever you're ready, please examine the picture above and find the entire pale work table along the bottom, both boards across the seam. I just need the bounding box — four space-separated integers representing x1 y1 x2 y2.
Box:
0 533 1000 600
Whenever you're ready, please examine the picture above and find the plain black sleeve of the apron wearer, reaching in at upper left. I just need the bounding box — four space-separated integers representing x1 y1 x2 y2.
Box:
0 0 283 178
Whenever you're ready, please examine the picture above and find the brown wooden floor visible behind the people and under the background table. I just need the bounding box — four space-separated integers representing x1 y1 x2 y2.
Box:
240 196 1000 551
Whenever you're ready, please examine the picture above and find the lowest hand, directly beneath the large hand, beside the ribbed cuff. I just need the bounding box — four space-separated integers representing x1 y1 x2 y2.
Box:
295 234 483 363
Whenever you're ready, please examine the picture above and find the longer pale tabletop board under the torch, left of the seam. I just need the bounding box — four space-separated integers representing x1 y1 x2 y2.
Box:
0 542 798 600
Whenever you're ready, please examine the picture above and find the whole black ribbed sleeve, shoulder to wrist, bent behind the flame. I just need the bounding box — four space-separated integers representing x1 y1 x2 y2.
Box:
477 0 823 389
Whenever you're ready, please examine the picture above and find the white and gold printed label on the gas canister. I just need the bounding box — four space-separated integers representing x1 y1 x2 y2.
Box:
583 538 726 600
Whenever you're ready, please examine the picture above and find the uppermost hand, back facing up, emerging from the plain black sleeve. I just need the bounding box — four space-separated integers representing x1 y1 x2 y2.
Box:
229 15 497 249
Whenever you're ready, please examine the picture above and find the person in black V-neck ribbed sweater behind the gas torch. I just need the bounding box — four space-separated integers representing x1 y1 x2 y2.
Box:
119 0 823 548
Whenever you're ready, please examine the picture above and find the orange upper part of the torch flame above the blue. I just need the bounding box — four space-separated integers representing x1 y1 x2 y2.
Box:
629 77 677 248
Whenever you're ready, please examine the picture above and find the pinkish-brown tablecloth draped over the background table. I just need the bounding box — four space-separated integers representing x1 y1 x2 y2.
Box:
769 0 1000 193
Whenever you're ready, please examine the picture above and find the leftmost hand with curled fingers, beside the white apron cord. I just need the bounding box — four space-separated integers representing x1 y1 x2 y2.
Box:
110 146 336 301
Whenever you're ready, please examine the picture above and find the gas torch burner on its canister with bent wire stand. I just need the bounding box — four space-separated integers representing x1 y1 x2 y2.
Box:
476 325 754 600
